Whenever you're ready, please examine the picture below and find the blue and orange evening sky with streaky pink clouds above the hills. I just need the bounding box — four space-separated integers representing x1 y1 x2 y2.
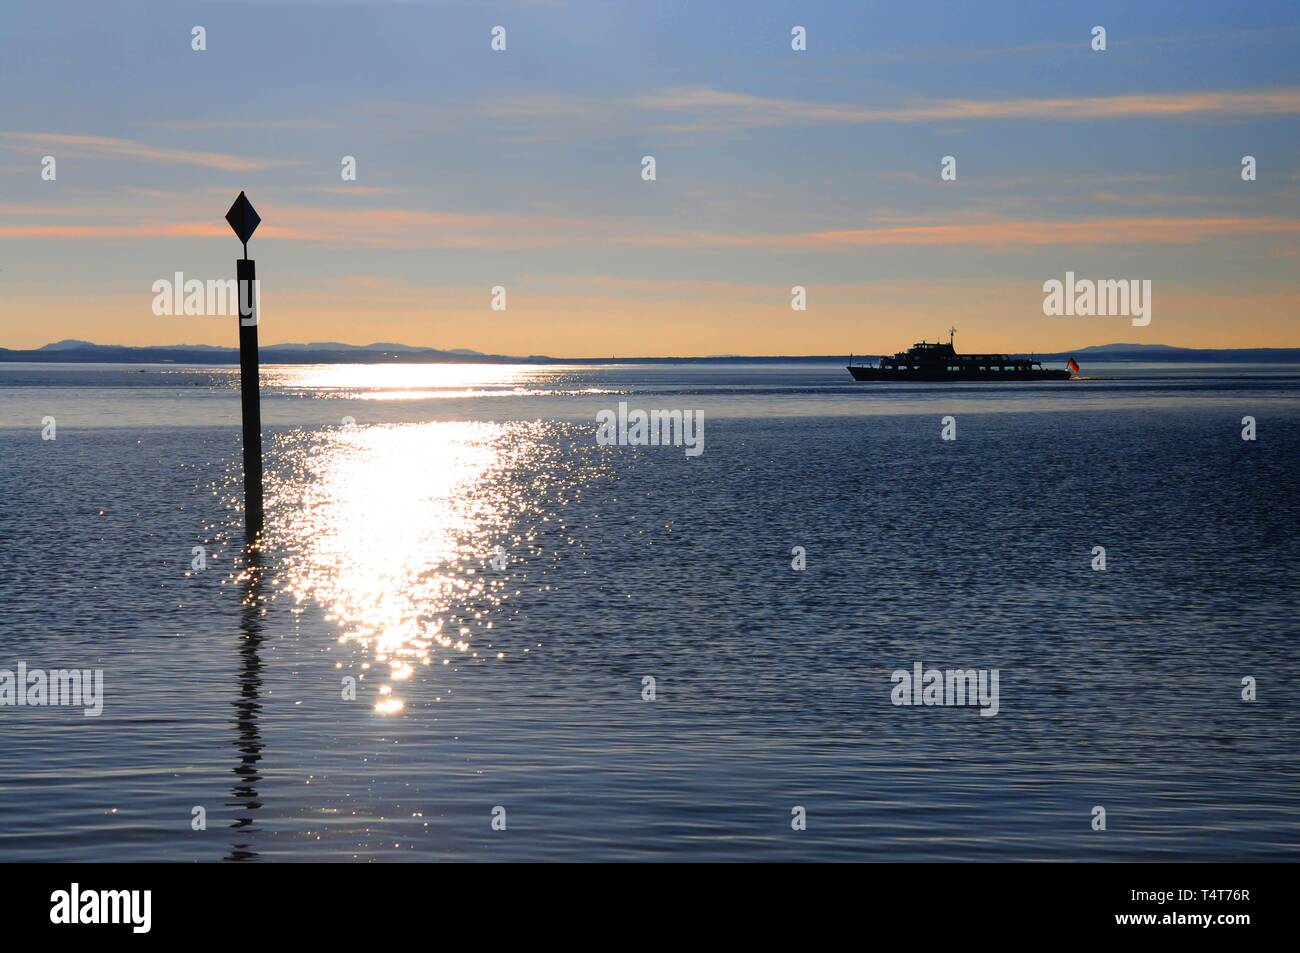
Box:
0 0 1300 358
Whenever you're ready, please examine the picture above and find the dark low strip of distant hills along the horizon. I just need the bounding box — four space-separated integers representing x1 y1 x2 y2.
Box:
0 339 1300 364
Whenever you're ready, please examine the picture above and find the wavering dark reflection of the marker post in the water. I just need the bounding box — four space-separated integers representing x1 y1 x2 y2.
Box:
225 546 265 861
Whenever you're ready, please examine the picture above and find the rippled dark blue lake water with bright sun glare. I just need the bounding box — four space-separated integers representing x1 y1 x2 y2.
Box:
0 365 1300 861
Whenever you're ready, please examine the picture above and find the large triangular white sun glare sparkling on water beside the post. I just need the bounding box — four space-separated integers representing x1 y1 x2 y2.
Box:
269 423 533 714
